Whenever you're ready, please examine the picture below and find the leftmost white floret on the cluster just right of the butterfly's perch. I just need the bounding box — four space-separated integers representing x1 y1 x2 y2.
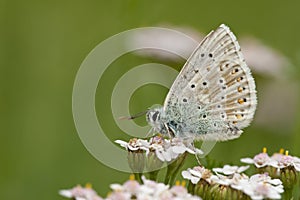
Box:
181 166 211 184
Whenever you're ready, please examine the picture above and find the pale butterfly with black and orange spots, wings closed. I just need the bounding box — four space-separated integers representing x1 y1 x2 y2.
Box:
146 24 257 141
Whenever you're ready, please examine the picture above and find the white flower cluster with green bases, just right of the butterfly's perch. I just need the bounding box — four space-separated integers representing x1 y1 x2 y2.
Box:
182 165 283 199
